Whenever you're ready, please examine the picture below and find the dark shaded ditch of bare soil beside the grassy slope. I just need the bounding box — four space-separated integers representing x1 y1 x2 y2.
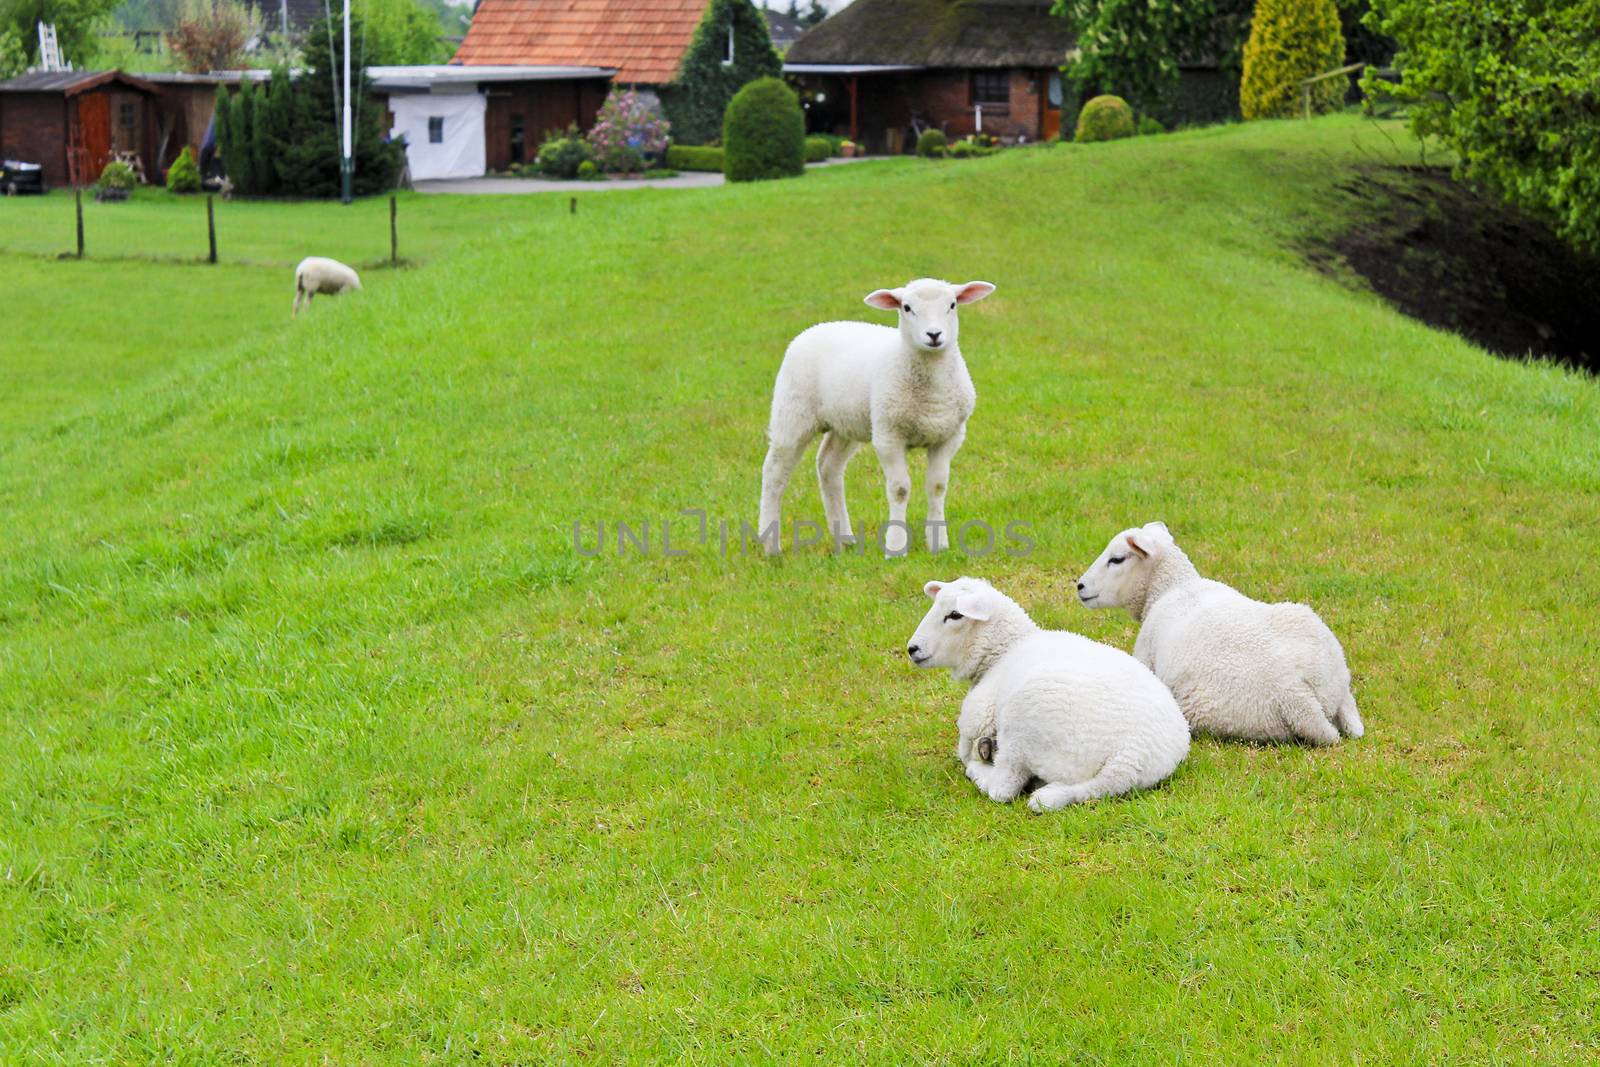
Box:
1307 166 1600 373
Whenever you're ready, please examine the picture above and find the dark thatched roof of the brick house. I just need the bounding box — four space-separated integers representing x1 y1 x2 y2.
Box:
784 0 1072 69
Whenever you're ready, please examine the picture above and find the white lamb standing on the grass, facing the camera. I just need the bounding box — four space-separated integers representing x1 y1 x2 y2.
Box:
758 278 995 555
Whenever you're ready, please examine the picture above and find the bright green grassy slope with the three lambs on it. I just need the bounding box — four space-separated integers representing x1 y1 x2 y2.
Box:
0 120 1600 1062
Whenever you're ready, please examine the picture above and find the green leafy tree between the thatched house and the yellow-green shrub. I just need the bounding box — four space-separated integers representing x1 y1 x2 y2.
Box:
1053 0 1253 112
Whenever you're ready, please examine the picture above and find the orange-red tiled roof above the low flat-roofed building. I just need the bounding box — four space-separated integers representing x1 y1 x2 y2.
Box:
454 0 709 85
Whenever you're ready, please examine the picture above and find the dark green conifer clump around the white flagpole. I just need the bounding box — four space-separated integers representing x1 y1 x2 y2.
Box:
216 16 403 197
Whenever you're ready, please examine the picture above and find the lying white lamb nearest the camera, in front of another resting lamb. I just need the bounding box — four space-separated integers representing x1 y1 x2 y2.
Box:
906 577 1189 811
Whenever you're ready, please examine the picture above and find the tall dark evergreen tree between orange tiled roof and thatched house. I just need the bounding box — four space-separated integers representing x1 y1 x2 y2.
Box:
661 0 784 144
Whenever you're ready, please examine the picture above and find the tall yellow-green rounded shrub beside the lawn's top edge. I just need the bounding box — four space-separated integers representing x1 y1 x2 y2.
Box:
1238 0 1349 118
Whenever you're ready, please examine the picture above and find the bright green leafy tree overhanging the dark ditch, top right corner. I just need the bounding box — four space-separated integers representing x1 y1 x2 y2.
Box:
1368 0 1600 251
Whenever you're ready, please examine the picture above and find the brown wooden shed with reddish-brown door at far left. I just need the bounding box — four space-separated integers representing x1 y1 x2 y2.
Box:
0 70 160 186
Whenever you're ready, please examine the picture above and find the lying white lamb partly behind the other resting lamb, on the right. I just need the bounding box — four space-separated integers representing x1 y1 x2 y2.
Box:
1078 523 1362 745
